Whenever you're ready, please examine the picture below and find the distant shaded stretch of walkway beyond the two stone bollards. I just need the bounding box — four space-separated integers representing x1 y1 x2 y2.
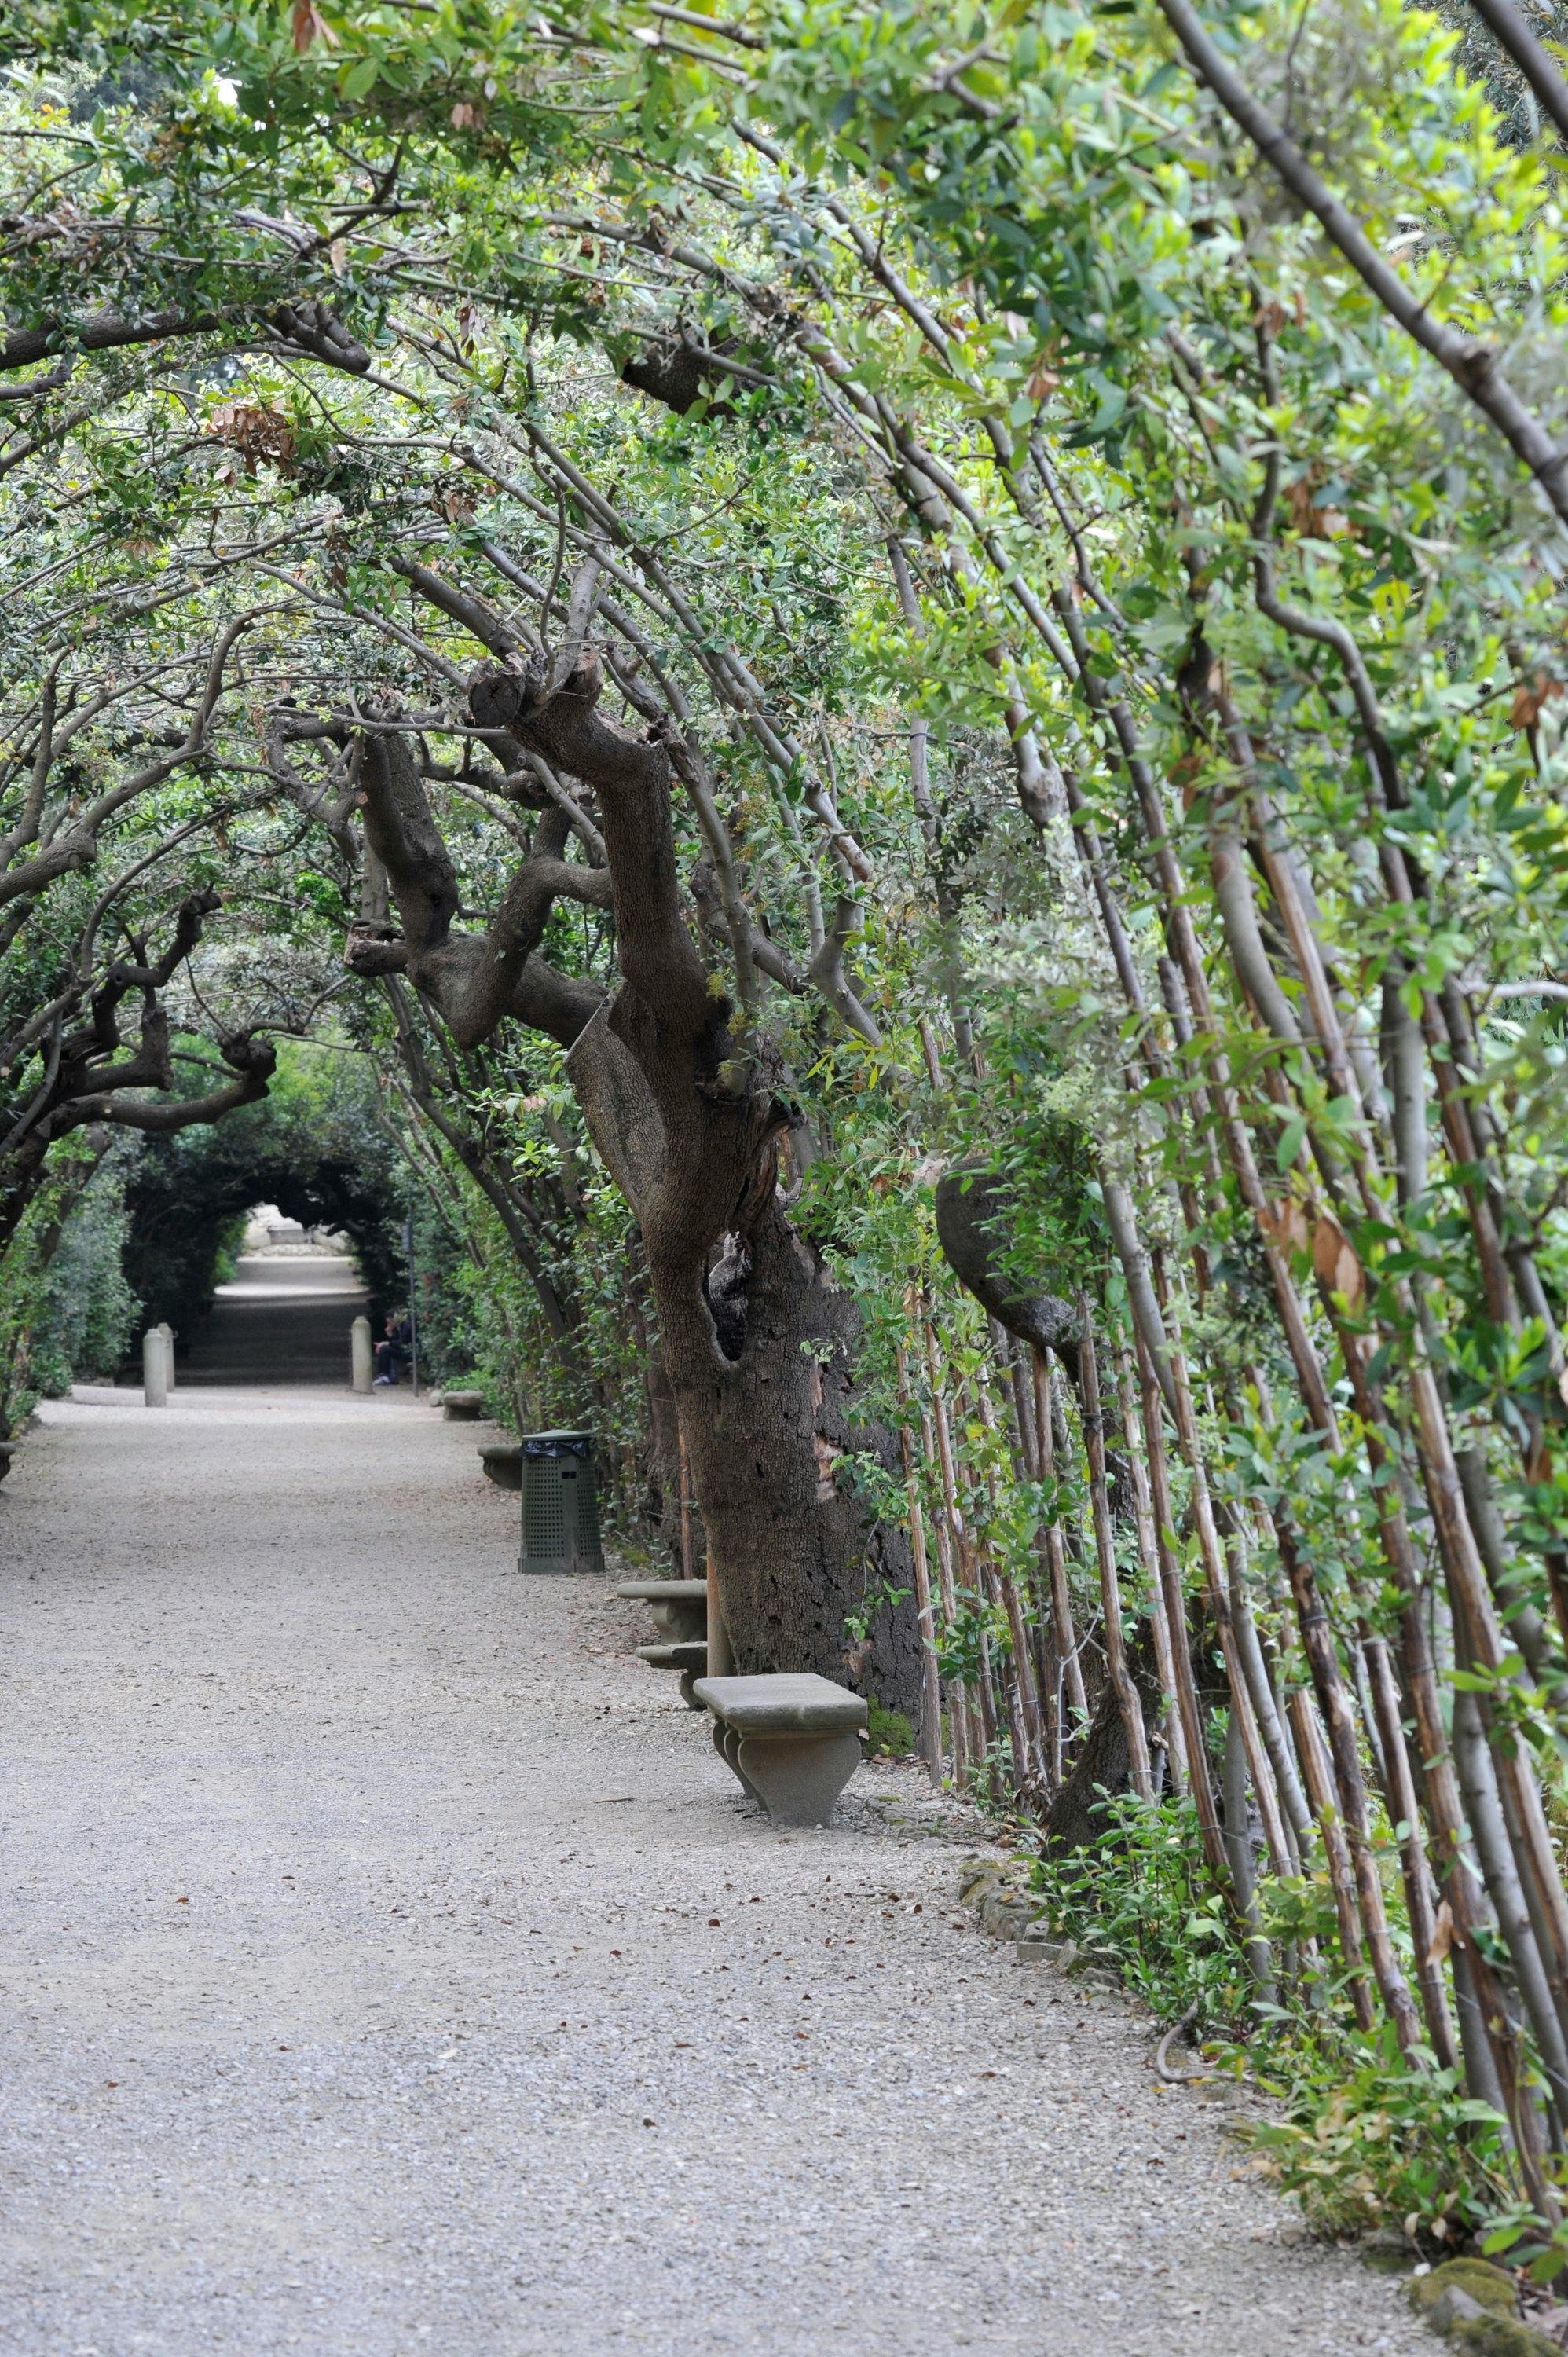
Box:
179 1254 368 1391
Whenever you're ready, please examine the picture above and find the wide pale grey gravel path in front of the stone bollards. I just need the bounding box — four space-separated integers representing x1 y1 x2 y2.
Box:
0 1388 1436 2357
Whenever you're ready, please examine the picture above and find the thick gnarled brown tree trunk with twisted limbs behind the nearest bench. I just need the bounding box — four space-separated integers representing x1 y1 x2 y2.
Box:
346 627 920 1709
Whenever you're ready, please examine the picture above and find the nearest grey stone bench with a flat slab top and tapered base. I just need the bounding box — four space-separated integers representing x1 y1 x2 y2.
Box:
693 1673 870 1824
